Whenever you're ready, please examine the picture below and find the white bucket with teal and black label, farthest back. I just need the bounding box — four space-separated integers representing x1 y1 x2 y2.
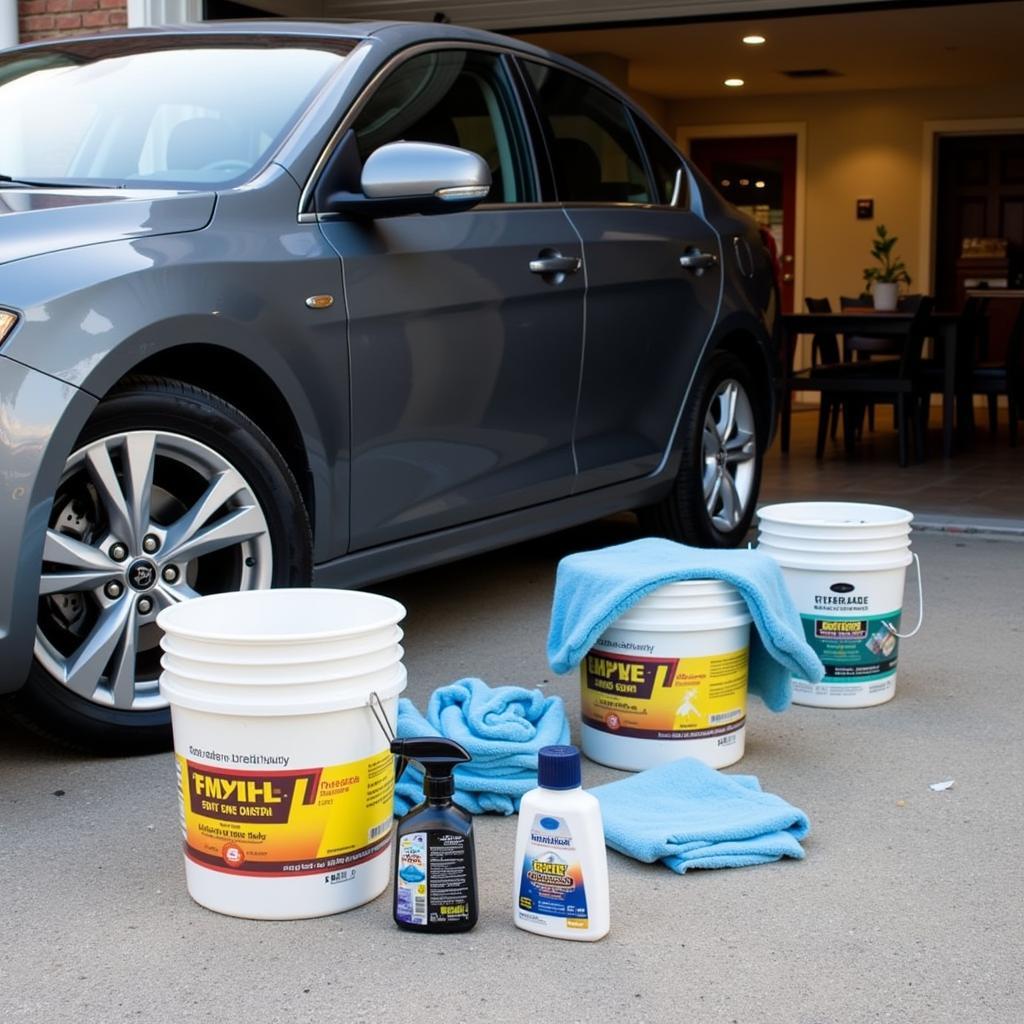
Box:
758 502 913 708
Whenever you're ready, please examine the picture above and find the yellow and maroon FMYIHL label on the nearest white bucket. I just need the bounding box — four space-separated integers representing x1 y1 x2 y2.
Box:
175 751 394 882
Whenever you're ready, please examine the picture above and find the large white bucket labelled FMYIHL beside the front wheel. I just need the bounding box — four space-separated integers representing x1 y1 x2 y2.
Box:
158 590 406 920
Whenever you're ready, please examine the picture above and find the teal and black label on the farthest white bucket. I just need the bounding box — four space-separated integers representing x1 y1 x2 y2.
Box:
800 611 900 684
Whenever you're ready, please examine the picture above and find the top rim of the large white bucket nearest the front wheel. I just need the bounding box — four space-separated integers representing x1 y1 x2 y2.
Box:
157 587 407 647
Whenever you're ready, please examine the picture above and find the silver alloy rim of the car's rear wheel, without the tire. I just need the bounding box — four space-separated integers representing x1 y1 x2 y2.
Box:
700 379 757 532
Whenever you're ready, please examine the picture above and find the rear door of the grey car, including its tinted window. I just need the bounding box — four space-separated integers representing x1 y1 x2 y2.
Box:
523 60 721 490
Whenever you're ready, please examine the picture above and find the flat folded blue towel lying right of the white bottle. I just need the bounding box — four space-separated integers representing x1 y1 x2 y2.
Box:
590 758 810 874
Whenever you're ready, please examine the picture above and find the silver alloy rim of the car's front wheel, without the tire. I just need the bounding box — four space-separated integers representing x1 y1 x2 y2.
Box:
35 430 273 711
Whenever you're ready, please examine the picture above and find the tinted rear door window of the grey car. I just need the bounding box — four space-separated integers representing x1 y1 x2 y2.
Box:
523 60 652 204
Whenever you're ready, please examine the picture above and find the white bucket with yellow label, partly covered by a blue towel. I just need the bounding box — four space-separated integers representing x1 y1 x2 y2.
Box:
580 580 751 771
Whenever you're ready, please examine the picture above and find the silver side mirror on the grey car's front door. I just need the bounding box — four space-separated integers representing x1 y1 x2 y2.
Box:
327 142 490 217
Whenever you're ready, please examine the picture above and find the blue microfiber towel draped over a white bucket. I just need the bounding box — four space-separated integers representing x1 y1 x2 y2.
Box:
548 538 824 711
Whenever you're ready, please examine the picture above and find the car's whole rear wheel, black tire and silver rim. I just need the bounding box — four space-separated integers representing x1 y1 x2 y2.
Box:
640 350 768 548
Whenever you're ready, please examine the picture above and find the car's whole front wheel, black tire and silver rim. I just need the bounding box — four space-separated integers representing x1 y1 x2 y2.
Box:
14 377 312 754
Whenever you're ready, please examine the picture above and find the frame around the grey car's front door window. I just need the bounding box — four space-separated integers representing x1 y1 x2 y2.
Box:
298 39 544 222
